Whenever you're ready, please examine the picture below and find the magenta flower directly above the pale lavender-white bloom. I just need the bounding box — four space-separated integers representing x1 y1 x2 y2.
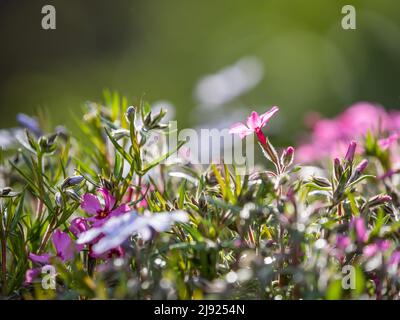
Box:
81 188 131 227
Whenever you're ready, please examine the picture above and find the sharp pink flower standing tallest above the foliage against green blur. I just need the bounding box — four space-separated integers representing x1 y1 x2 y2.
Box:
229 107 279 145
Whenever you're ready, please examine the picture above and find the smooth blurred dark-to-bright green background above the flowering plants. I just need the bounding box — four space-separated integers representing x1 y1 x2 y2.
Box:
0 0 400 141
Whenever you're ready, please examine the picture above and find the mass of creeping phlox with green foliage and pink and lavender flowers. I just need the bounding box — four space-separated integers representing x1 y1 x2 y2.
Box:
0 94 400 299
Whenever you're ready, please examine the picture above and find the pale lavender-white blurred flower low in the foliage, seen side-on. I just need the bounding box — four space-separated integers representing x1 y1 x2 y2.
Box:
77 211 189 254
